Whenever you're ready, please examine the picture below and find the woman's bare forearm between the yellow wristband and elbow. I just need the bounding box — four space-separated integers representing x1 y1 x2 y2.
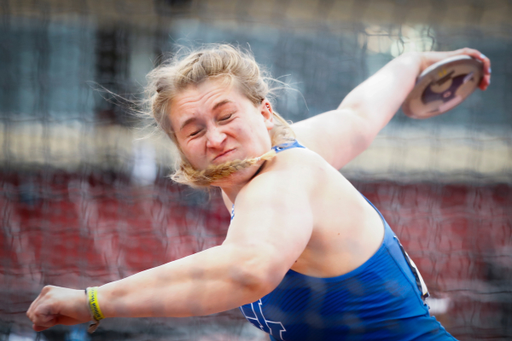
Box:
98 246 272 317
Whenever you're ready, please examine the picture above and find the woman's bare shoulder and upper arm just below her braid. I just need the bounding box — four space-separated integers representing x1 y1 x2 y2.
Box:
224 149 319 274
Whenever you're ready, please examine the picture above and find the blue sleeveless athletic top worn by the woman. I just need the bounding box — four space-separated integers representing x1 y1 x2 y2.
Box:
236 142 454 341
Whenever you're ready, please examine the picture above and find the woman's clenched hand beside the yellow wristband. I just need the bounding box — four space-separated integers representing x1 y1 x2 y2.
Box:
27 285 91 332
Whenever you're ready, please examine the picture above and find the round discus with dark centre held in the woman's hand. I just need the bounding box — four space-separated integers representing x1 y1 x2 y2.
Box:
402 56 484 119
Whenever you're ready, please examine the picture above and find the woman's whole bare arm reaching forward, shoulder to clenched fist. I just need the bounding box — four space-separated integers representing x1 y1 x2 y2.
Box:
27 159 313 331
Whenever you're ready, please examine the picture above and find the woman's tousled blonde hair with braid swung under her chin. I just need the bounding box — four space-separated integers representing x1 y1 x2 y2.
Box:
146 44 295 187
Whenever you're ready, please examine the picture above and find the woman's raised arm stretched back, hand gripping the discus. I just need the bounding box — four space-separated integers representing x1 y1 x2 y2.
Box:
292 48 490 169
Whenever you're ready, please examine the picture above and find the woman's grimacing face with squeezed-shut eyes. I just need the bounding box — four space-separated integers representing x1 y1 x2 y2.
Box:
169 80 274 169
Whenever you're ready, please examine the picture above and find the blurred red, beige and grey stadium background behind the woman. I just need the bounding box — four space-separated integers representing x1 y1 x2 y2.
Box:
0 0 512 340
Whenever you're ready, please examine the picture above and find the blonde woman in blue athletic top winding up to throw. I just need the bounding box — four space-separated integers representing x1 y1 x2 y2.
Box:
27 45 490 340
